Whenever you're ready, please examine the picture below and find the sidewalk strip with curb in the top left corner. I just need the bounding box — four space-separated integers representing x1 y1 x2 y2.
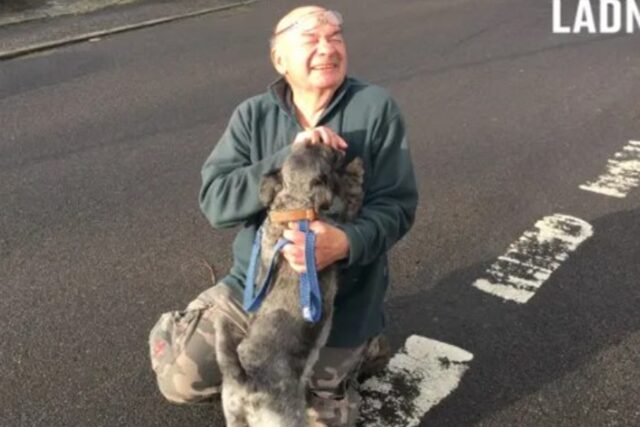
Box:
0 0 255 61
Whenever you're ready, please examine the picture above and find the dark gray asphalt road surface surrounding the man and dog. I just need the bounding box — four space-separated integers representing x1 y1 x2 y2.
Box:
0 0 640 426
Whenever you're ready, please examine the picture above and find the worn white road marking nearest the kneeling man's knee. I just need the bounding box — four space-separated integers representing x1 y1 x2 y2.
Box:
358 335 473 427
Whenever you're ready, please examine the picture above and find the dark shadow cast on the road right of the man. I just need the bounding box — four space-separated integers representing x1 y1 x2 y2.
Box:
389 210 640 426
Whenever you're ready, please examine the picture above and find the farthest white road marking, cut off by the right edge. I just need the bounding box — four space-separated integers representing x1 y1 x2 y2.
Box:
580 141 640 198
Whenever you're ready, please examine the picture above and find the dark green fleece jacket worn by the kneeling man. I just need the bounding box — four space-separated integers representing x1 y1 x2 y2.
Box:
200 78 418 347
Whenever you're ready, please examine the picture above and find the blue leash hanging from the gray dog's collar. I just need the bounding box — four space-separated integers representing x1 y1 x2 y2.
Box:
243 220 322 323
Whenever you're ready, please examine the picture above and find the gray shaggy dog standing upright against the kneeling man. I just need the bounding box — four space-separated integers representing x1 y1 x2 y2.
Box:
215 143 364 427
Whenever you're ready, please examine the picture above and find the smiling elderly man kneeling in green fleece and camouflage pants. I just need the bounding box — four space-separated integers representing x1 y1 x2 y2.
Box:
150 6 417 426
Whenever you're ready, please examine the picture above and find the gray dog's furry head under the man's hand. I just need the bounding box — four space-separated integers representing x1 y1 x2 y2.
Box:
260 143 363 212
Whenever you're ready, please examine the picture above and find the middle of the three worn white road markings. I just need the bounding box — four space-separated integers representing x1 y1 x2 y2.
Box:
473 214 593 304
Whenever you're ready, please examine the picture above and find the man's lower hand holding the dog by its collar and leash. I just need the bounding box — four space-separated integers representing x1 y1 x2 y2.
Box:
282 221 349 274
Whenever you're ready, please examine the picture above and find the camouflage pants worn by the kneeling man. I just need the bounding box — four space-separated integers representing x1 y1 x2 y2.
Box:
149 283 366 427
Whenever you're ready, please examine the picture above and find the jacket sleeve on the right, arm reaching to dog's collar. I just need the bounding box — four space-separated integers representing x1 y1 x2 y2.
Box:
339 114 418 266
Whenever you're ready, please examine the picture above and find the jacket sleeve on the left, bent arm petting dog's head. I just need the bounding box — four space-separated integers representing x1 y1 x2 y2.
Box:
199 106 291 228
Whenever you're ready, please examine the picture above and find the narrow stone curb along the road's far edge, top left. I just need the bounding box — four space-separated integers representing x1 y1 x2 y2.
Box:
0 0 258 61
